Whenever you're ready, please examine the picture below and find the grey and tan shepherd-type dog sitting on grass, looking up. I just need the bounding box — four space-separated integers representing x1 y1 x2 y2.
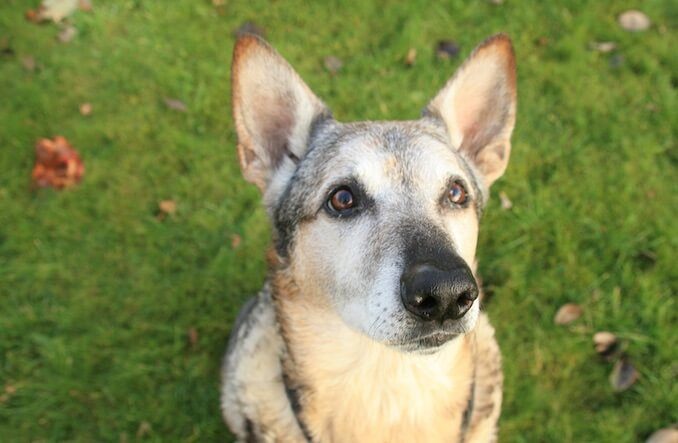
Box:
221 34 516 443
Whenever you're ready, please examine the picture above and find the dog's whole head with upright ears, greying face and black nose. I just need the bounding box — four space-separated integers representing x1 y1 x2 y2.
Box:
233 35 516 351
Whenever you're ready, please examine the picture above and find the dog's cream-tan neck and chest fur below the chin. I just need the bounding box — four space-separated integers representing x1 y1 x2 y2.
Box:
273 258 473 441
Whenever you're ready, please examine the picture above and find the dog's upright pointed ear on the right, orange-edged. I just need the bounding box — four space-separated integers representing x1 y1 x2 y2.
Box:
424 34 516 187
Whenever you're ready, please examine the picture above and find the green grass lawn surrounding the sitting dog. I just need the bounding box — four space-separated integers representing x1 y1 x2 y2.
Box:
0 0 678 442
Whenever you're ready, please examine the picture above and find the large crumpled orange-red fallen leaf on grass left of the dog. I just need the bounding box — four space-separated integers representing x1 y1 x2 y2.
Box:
32 136 85 189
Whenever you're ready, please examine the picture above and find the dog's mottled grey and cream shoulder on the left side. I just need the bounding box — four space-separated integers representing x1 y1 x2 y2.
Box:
221 285 300 441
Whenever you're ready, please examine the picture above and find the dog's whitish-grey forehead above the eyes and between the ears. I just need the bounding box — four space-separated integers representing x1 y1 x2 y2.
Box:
316 121 467 196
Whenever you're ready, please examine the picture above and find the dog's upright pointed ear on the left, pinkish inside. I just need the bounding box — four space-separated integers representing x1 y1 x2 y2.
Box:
231 35 330 192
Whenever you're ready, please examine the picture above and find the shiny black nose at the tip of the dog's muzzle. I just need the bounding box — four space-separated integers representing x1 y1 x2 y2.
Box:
400 265 478 321
